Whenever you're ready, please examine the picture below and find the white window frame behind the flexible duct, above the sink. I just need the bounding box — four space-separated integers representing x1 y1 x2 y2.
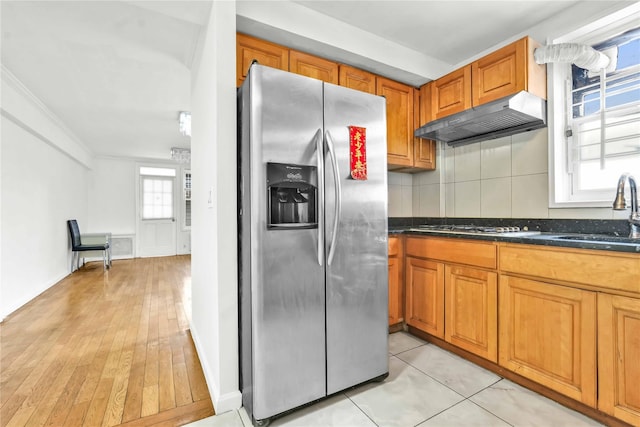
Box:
547 3 640 208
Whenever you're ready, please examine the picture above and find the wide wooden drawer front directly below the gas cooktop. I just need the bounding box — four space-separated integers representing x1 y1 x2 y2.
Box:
406 237 497 269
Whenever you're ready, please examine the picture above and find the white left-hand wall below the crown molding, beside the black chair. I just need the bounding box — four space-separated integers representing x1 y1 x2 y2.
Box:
0 115 87 319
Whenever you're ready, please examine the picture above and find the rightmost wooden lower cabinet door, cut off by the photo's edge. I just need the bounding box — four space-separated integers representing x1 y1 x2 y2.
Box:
598 293 640 426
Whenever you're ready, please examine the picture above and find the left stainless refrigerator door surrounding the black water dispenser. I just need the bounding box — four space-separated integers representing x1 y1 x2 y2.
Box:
243 65 326 419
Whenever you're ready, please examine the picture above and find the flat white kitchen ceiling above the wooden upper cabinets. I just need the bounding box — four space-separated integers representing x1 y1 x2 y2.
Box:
295 0 577 64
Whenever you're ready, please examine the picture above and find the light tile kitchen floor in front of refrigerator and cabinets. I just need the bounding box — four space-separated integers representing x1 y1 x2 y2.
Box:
189 332 602 427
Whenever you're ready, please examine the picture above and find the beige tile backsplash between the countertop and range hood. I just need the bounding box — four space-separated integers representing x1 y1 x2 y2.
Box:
388 129 628 219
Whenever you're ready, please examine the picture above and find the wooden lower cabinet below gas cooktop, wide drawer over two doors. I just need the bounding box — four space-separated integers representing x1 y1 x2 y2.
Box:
405 237 497 352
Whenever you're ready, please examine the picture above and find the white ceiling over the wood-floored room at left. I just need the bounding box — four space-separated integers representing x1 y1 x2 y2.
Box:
1 1 211 159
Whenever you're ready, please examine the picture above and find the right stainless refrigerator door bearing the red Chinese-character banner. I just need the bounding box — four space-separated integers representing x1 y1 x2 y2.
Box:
324 84 388 394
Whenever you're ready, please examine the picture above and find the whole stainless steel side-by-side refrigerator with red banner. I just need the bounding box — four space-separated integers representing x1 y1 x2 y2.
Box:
238 64 388 425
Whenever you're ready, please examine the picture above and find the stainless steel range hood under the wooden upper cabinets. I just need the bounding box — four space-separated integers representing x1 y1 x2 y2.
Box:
414 91 547 146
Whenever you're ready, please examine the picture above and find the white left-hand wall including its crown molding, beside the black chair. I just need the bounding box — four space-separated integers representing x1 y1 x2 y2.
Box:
0 67 92 319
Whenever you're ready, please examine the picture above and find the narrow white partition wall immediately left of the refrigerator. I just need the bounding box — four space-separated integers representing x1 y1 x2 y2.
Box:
191 2 241 413
